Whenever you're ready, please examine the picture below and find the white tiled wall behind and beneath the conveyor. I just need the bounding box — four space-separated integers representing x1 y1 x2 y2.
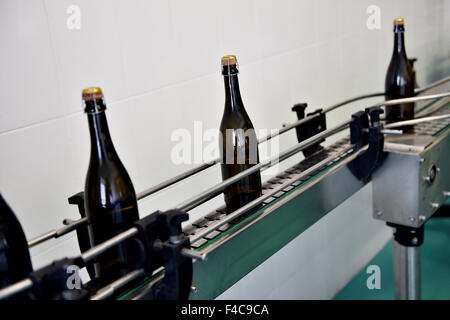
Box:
0 0 450 298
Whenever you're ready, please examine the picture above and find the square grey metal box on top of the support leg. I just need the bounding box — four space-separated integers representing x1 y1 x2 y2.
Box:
372 114 450 228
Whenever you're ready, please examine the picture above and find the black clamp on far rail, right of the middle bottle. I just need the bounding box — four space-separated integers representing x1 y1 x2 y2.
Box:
292 103 327 157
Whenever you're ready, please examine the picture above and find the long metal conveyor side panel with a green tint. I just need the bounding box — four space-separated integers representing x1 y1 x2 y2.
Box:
190 151 364 299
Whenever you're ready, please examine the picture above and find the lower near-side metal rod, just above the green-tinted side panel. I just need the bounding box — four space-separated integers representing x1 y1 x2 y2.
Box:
191 145 354 243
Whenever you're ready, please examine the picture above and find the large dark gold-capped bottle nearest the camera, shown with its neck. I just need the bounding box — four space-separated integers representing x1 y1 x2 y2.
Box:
82 87 139 284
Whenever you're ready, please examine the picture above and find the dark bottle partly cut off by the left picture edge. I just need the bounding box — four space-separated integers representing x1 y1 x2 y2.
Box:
0 194 33 288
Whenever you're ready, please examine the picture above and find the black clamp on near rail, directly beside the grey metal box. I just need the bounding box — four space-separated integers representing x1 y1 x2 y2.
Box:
347 107 384 180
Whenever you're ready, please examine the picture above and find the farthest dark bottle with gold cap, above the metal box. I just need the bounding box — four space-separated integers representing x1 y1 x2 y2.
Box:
385 18 414 131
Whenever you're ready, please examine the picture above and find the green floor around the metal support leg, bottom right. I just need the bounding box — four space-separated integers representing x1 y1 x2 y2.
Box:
335 218 450 300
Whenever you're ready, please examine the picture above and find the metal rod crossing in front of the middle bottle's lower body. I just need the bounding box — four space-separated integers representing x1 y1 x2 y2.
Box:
175 120 352 211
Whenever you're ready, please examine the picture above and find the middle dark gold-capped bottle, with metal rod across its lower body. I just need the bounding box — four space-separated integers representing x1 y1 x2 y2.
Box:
219 55 261 213
